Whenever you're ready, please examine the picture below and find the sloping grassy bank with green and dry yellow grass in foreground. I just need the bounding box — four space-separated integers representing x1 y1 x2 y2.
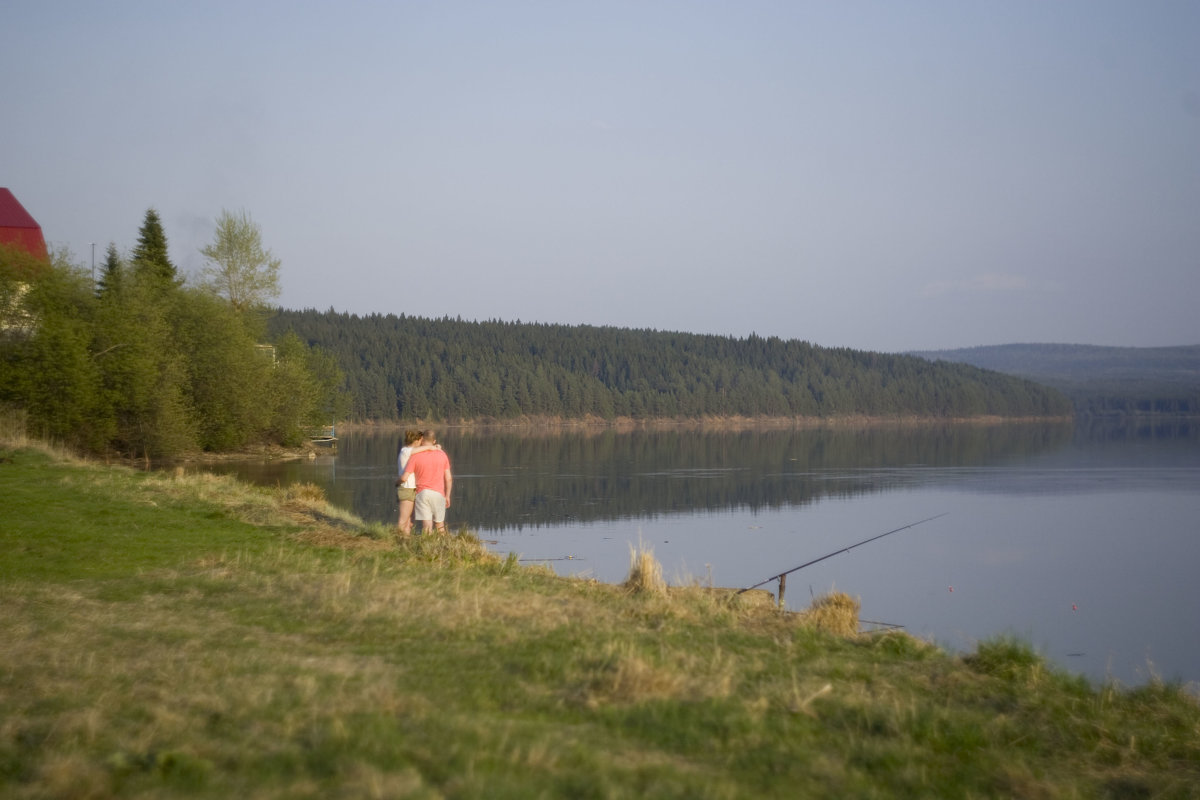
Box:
0 446 1200 798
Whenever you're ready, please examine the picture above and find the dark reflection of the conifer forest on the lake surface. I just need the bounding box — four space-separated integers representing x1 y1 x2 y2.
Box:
337 425 1072 530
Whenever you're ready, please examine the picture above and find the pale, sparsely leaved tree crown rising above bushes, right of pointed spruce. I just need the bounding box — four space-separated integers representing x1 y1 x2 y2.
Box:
200 211 280 312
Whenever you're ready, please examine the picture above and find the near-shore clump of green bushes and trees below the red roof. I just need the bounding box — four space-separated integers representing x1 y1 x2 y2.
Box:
0 209 348 458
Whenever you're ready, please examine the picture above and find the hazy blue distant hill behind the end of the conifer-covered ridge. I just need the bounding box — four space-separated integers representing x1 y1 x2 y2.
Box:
908 344 1200 416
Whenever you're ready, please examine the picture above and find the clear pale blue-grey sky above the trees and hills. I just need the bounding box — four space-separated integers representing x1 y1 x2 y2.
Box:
0 0 1200 351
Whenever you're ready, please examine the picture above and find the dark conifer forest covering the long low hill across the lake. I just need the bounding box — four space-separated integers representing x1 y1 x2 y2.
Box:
268 308 1072 422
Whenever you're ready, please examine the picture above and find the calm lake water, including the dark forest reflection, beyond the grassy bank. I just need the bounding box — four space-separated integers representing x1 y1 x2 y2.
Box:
189 425 1200 684
